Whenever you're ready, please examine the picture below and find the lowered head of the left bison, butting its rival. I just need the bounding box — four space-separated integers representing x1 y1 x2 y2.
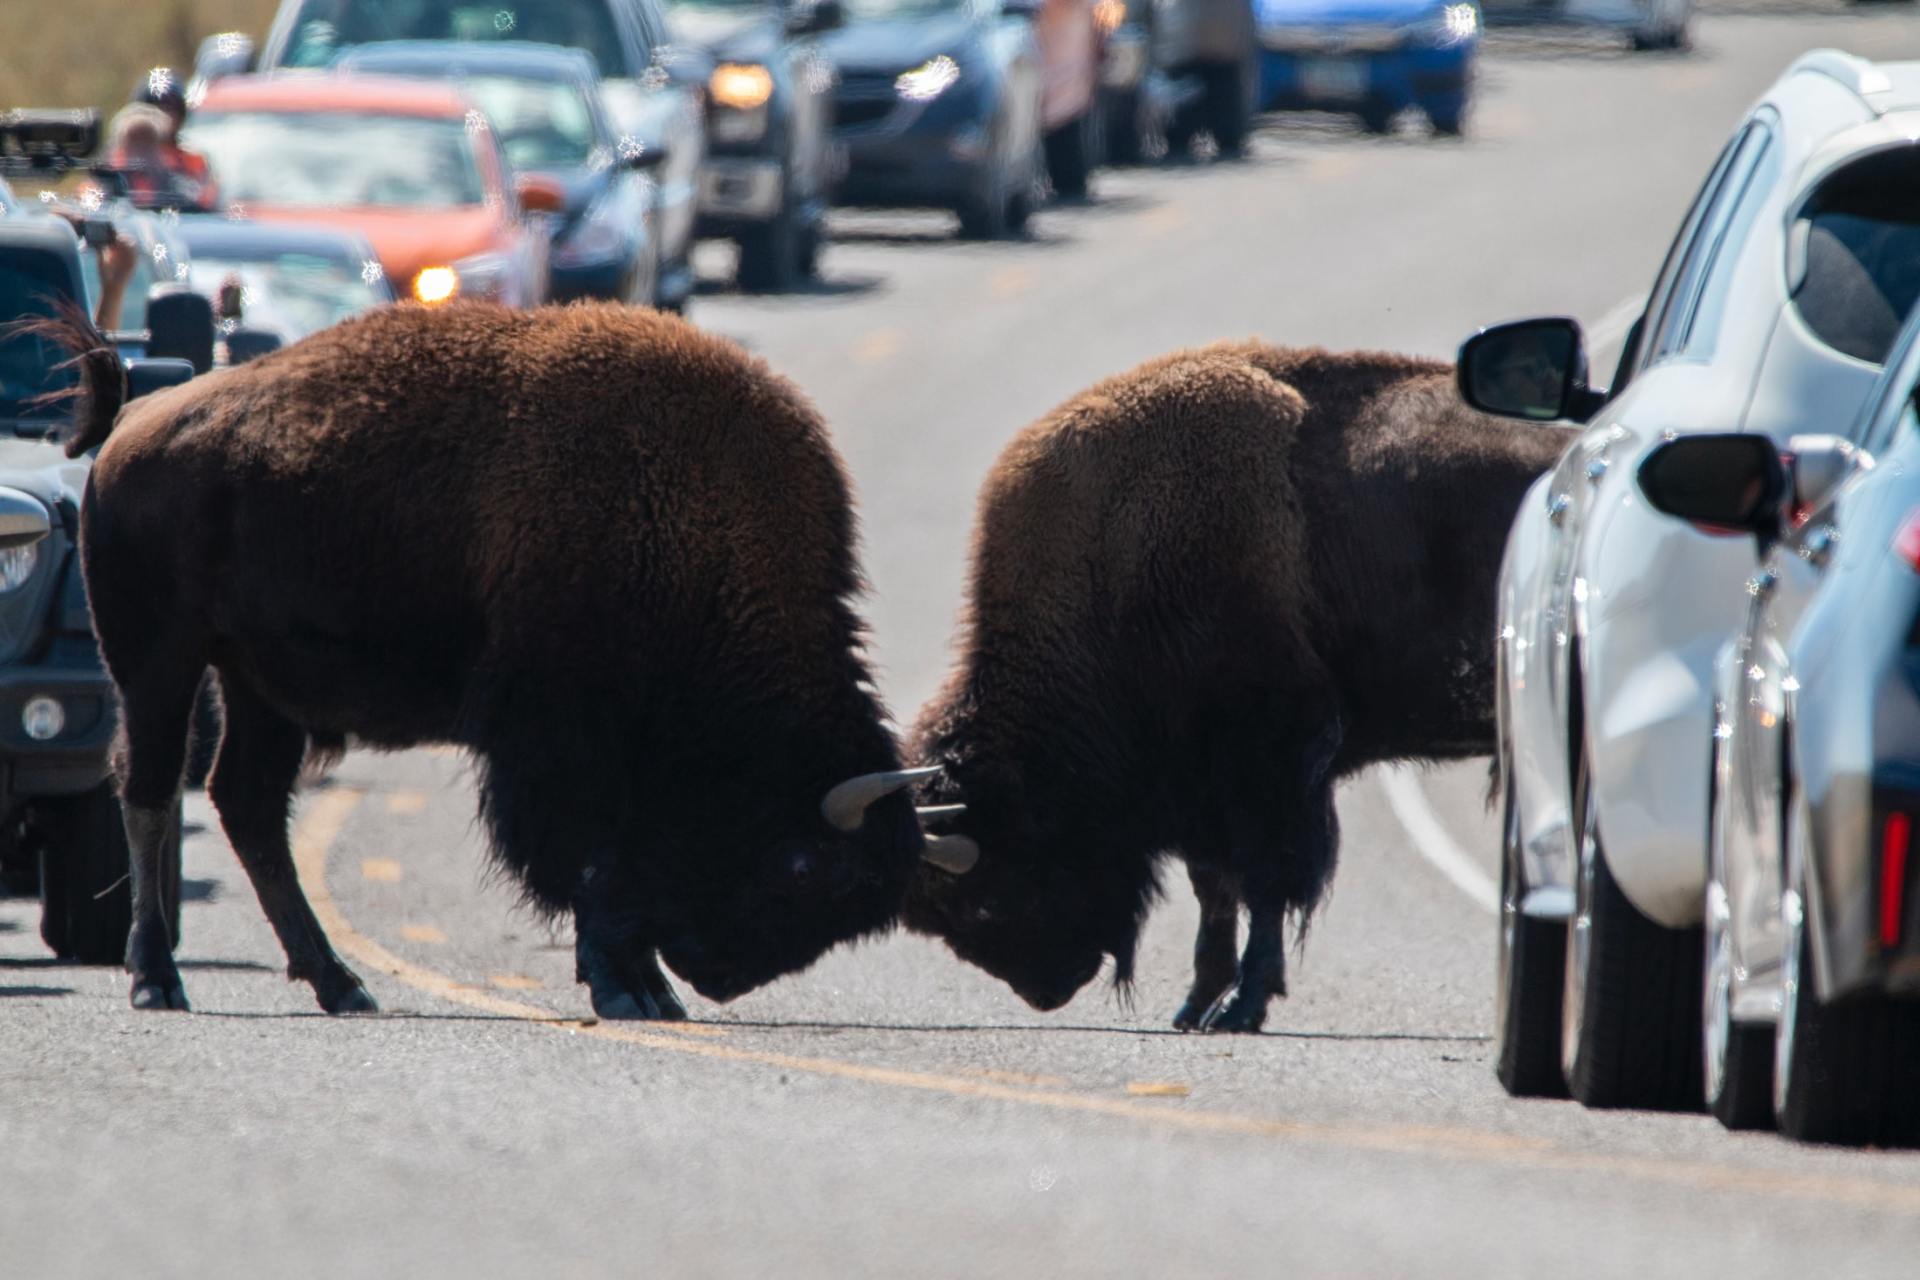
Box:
660 770 960 1002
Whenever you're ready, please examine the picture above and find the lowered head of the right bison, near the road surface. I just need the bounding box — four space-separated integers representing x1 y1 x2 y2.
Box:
904 771 1140 1011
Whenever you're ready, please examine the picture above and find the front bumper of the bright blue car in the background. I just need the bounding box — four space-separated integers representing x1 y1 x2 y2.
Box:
1260 40 1478 113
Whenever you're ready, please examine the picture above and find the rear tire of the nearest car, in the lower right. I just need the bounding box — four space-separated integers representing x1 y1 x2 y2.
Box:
1774 867 1920 1146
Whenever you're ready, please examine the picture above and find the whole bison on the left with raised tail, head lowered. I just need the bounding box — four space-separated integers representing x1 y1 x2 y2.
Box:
54 305 944 1017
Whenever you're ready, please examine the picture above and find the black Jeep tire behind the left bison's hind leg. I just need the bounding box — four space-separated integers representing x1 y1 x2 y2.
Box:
31 781 180 965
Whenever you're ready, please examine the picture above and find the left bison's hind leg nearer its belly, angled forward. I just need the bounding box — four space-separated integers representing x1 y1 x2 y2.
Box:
207 674 378 1013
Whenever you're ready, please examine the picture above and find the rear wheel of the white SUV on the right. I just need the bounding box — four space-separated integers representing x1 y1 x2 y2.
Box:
1561 750 1703 1111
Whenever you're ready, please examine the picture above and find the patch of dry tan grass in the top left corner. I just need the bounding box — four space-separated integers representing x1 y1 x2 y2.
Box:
0 0 280 115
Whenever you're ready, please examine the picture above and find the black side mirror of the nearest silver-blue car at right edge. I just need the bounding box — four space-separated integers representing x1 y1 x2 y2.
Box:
1640 432 1791 539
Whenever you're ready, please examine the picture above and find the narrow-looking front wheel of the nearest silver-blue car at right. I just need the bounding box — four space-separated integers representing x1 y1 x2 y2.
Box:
1701 739 1774 1128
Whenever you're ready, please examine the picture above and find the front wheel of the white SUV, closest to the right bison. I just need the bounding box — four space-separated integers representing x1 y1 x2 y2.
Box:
1494 775 1567 1098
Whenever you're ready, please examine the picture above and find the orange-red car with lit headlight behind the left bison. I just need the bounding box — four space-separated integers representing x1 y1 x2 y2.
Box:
184 75 566 307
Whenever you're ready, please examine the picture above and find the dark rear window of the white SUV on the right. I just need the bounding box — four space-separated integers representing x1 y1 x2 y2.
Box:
1793 146 1920 365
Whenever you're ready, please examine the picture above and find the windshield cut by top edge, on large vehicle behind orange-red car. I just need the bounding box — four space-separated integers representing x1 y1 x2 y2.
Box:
284 0 643 77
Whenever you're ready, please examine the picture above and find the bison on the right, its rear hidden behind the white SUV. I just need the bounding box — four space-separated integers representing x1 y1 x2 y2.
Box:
906 344 1565 1031
